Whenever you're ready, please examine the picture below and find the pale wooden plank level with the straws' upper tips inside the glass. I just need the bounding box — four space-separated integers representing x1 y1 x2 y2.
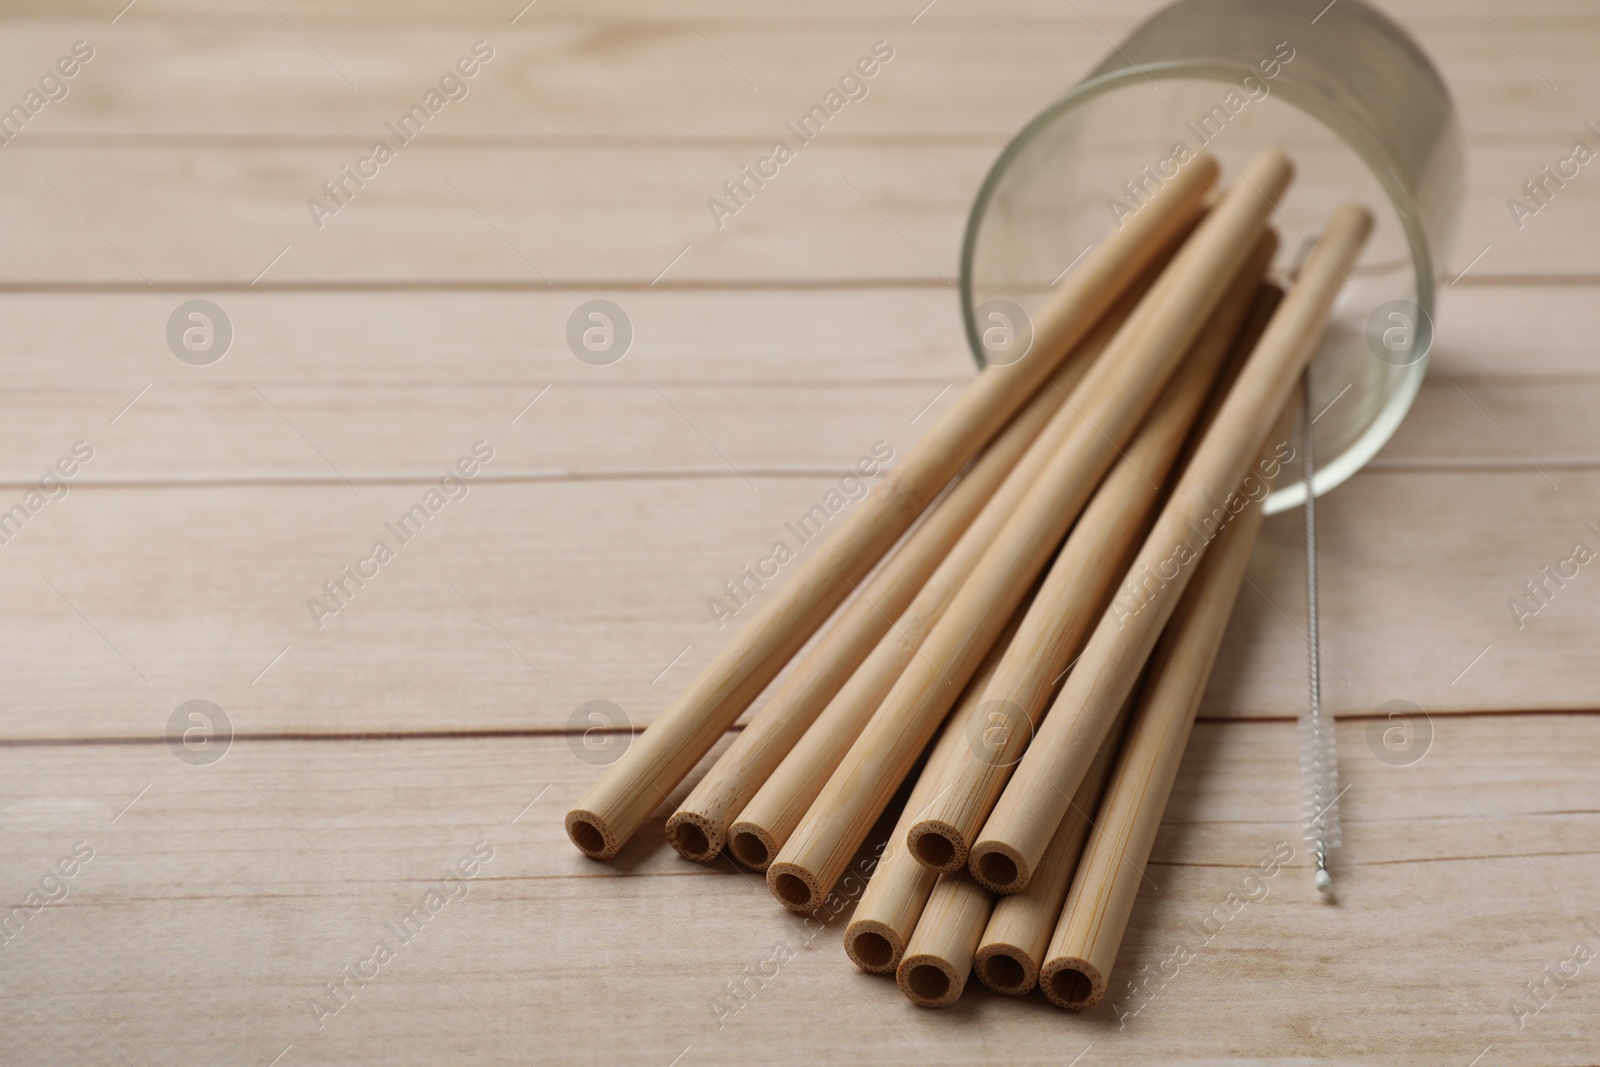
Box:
0 134 1600 286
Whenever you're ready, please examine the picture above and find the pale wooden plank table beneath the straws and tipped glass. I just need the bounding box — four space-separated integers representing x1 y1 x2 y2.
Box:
0 0 1600 1067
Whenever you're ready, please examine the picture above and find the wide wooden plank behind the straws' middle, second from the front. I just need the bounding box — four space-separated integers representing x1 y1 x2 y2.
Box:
0 470 1600 737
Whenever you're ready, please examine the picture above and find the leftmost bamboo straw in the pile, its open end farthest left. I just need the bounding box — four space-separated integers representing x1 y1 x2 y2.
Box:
566 157 1216 859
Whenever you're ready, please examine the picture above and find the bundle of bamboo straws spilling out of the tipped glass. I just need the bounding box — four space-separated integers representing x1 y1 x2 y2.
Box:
566 150 1371 1009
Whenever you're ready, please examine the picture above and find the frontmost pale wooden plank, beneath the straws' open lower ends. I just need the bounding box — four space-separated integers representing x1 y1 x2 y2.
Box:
0 715 1600 1064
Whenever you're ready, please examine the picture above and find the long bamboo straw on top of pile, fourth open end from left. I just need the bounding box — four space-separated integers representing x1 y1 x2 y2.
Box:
766 152 1291 912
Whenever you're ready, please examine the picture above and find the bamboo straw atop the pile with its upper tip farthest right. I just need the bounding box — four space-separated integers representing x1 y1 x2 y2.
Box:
966 203 1371 893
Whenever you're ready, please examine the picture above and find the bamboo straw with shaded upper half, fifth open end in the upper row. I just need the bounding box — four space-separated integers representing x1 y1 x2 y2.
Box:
907 230 1278 881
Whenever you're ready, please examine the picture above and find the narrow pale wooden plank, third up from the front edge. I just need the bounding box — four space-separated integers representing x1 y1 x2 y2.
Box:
0 367 1600 488
